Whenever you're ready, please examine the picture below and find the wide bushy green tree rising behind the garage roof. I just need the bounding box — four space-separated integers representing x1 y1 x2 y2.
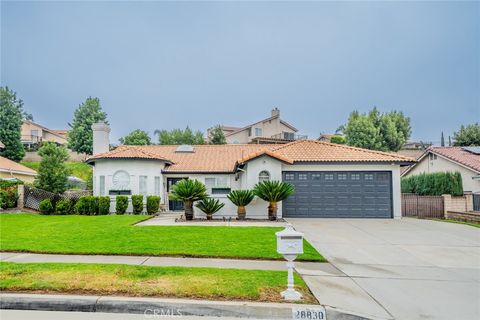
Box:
344 108 411 151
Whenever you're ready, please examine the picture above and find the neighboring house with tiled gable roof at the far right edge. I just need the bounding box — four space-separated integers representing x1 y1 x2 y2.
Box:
402 147 480 192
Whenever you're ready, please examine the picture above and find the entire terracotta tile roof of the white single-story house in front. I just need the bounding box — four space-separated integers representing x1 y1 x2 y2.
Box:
87 140 414 172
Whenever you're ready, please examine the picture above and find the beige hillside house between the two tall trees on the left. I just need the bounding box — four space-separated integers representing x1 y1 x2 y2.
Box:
22 120 68 145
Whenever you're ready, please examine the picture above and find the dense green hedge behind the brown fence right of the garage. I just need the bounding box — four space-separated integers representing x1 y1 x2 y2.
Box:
401 172 463 196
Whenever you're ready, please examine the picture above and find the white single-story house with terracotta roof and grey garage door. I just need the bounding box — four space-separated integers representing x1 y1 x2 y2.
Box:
87 123 414 218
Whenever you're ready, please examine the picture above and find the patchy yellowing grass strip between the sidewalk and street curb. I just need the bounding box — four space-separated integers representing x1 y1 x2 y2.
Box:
0 262 317 303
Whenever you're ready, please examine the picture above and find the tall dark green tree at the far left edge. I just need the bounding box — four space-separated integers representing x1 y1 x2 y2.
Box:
0 87 25 162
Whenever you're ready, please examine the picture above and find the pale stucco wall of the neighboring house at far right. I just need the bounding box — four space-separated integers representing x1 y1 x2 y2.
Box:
405 155 480 192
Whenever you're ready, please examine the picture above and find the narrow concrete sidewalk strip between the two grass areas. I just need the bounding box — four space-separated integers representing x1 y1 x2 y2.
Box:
0 252 343 276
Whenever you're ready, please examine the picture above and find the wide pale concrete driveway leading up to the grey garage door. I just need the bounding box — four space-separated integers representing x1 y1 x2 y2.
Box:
288 218 480 320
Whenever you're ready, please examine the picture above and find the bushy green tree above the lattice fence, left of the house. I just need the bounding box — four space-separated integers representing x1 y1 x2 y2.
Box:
34 142 70 193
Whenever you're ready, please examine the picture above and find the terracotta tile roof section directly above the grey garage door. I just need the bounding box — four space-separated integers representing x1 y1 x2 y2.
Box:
273 140 415 162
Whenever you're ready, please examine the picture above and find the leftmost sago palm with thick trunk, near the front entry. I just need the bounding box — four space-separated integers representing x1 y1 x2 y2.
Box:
170 180 208 220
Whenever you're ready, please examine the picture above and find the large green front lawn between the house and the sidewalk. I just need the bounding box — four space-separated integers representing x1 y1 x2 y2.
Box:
0 214 325 261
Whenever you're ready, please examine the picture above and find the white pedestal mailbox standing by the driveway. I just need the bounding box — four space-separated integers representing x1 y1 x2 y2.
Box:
275 224 303 300
